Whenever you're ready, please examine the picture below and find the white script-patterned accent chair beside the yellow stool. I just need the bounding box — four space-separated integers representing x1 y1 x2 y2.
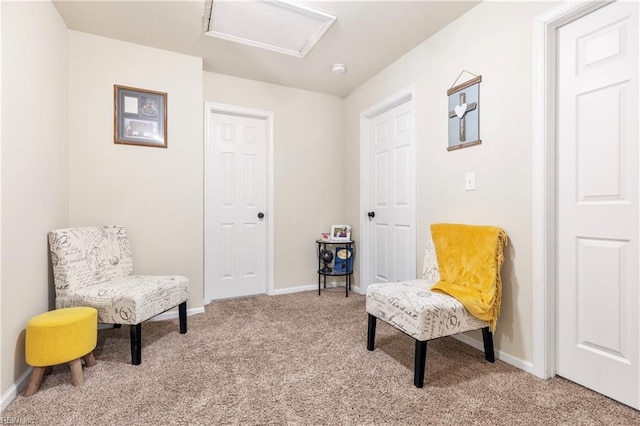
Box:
49 226 189 365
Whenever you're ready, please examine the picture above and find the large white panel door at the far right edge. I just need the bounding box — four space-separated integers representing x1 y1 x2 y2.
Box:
556 2 640 408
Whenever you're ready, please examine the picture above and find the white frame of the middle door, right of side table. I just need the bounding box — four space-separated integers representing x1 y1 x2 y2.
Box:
358 85 418 294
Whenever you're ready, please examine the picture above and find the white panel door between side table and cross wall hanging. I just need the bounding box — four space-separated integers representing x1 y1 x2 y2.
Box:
367 101 416 283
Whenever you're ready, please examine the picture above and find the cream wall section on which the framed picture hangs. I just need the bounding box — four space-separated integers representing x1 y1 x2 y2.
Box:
68 31 204 309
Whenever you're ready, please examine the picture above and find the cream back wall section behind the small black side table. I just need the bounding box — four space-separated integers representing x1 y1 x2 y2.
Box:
204 72 344 292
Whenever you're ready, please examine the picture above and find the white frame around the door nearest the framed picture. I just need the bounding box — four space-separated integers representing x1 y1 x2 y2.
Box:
204 102 275 305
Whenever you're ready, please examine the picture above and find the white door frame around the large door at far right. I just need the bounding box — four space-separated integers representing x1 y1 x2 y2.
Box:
532 0 614 379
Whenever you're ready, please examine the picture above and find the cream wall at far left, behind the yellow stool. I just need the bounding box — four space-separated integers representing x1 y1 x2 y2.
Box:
0 2 68 402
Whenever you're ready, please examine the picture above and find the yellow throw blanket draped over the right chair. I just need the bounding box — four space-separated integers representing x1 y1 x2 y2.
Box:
431 223 507 332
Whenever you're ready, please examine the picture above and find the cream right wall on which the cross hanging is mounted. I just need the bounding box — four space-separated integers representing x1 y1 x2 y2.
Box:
345 2 555 365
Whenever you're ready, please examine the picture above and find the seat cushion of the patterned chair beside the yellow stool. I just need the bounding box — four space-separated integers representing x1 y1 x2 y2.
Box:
56 275 189 325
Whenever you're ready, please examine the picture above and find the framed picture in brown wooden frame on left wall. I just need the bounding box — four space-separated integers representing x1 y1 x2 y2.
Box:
113 84 167 148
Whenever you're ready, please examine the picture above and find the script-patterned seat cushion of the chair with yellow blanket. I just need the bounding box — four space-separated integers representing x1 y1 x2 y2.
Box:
367 280 489 340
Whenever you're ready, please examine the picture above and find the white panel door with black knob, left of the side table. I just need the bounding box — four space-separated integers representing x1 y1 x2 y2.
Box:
206 112 267 299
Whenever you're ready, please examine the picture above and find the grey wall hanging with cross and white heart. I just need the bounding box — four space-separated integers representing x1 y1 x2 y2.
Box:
447 75 482 151
